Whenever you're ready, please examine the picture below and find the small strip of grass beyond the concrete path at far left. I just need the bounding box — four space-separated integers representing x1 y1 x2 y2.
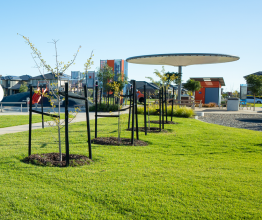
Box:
0 114 64 128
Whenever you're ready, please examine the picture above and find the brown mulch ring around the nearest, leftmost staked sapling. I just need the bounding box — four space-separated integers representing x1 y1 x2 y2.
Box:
23 153 91 167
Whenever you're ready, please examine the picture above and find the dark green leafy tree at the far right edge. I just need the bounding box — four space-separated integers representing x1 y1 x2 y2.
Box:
245 74 262 111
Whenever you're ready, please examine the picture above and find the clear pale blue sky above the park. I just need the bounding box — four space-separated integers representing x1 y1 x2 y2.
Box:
0 0 262 91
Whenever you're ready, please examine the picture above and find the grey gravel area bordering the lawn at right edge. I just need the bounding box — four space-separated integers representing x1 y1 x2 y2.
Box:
198 113 262 131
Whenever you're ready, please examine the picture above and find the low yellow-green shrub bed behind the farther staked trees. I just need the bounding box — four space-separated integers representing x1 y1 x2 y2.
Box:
137 105 194 118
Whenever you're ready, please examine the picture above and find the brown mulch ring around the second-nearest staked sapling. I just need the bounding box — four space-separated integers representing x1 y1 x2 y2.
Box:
92 137 148 146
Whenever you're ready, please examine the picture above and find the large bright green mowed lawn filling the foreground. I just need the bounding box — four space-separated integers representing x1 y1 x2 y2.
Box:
0 115 262 219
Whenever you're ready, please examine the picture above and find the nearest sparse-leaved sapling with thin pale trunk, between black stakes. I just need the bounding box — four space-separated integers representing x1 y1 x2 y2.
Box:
18 34 93 161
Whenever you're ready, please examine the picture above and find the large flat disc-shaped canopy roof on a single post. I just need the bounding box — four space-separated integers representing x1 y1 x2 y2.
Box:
126 53 239 66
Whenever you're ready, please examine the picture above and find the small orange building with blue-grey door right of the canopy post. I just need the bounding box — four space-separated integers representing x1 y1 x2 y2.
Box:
190 77 225 104
